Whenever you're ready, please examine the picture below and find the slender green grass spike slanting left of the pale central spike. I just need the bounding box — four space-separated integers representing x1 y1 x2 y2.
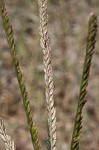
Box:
0 0 41 150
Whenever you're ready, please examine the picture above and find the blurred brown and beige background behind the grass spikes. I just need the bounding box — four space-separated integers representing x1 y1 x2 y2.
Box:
0 0 99 150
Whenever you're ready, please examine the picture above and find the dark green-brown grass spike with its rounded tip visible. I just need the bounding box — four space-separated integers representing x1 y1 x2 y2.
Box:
71 13 97 150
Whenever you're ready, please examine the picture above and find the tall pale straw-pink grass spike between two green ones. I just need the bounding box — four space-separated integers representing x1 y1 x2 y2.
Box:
38 0 56 150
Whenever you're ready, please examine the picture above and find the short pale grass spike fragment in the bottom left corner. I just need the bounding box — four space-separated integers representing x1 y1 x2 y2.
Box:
0 118 16 150
